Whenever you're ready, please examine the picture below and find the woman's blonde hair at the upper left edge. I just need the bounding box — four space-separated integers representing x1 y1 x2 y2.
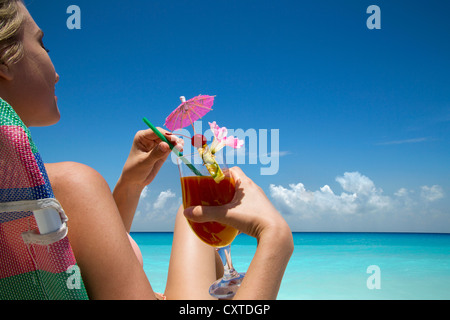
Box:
0 0 24 64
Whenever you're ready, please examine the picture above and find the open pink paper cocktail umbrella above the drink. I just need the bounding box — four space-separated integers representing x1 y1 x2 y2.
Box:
164 95 214 131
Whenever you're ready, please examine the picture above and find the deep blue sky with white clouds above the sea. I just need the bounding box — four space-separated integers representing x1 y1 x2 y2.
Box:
25 0 450 233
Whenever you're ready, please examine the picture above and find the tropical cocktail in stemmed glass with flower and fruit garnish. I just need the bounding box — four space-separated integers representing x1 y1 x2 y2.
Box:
178 128 245 299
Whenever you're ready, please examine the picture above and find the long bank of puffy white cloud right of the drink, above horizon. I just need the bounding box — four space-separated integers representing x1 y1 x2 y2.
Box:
269 172 450 232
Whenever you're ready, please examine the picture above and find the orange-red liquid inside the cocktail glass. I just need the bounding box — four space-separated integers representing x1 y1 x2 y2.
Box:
181 176 238 248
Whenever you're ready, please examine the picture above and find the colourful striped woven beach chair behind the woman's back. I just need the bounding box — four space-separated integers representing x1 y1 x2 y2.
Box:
0 99 88 300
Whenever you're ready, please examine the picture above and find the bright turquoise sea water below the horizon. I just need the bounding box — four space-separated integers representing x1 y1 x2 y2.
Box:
132 233 450 300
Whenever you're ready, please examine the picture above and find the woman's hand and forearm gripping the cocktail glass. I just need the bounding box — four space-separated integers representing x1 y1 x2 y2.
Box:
184 168 294 299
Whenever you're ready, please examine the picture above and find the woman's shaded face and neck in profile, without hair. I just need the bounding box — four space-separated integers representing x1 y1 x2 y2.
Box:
0 4 60 127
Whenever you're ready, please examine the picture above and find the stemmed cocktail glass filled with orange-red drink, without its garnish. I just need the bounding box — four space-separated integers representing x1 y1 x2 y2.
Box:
178 155 245 299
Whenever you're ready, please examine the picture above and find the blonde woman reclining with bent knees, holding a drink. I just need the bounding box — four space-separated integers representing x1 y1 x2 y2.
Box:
0 0 293 299
